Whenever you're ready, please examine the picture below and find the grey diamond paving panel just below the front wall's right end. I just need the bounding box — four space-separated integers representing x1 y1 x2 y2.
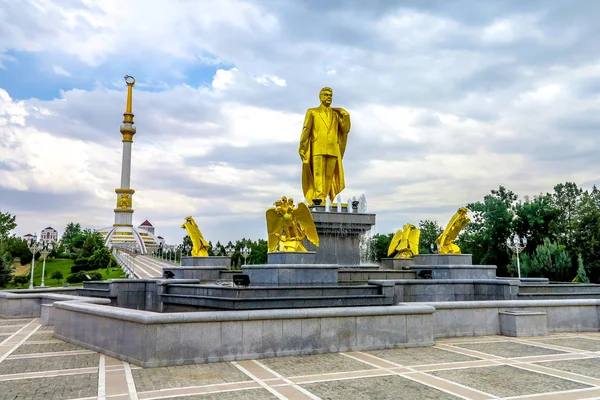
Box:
364 347 478 366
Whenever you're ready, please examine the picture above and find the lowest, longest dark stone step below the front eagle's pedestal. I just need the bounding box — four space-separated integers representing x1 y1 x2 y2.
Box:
161 294 394 310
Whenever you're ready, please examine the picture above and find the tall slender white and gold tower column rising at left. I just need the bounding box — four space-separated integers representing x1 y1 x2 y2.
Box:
113 75 135 227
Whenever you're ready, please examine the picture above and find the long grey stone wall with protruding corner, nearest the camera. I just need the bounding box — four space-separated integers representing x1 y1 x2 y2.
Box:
55 303 434 367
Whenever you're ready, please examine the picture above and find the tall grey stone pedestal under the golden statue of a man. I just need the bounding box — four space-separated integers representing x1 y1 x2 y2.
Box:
303 206 375 265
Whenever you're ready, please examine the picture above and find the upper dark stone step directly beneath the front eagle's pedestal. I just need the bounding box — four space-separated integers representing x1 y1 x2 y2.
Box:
165 284 380 298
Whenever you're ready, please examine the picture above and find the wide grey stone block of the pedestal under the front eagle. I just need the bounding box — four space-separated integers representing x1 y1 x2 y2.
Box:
242 264 338 286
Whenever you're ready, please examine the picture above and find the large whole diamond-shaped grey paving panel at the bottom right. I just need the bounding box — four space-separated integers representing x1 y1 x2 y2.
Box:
431 365 591 397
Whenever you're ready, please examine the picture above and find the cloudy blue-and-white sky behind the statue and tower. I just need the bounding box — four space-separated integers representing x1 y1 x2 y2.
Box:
0 0 600 243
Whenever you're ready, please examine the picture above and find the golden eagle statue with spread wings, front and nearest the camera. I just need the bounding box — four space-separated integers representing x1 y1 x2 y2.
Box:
266 196 319 253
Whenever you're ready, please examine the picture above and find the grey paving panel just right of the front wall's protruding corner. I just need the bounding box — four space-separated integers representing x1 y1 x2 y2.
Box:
131 363 250 391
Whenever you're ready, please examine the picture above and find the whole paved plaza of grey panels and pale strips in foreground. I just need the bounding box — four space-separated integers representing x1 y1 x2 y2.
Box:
0 319 600 400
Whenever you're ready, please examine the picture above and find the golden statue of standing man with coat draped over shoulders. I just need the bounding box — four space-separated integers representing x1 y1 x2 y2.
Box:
298 87 350 203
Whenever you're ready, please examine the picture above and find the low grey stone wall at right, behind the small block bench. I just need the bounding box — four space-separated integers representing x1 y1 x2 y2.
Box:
420 300 600 338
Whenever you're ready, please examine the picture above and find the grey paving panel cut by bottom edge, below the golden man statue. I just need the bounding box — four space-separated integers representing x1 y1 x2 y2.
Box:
302 375 459 400
